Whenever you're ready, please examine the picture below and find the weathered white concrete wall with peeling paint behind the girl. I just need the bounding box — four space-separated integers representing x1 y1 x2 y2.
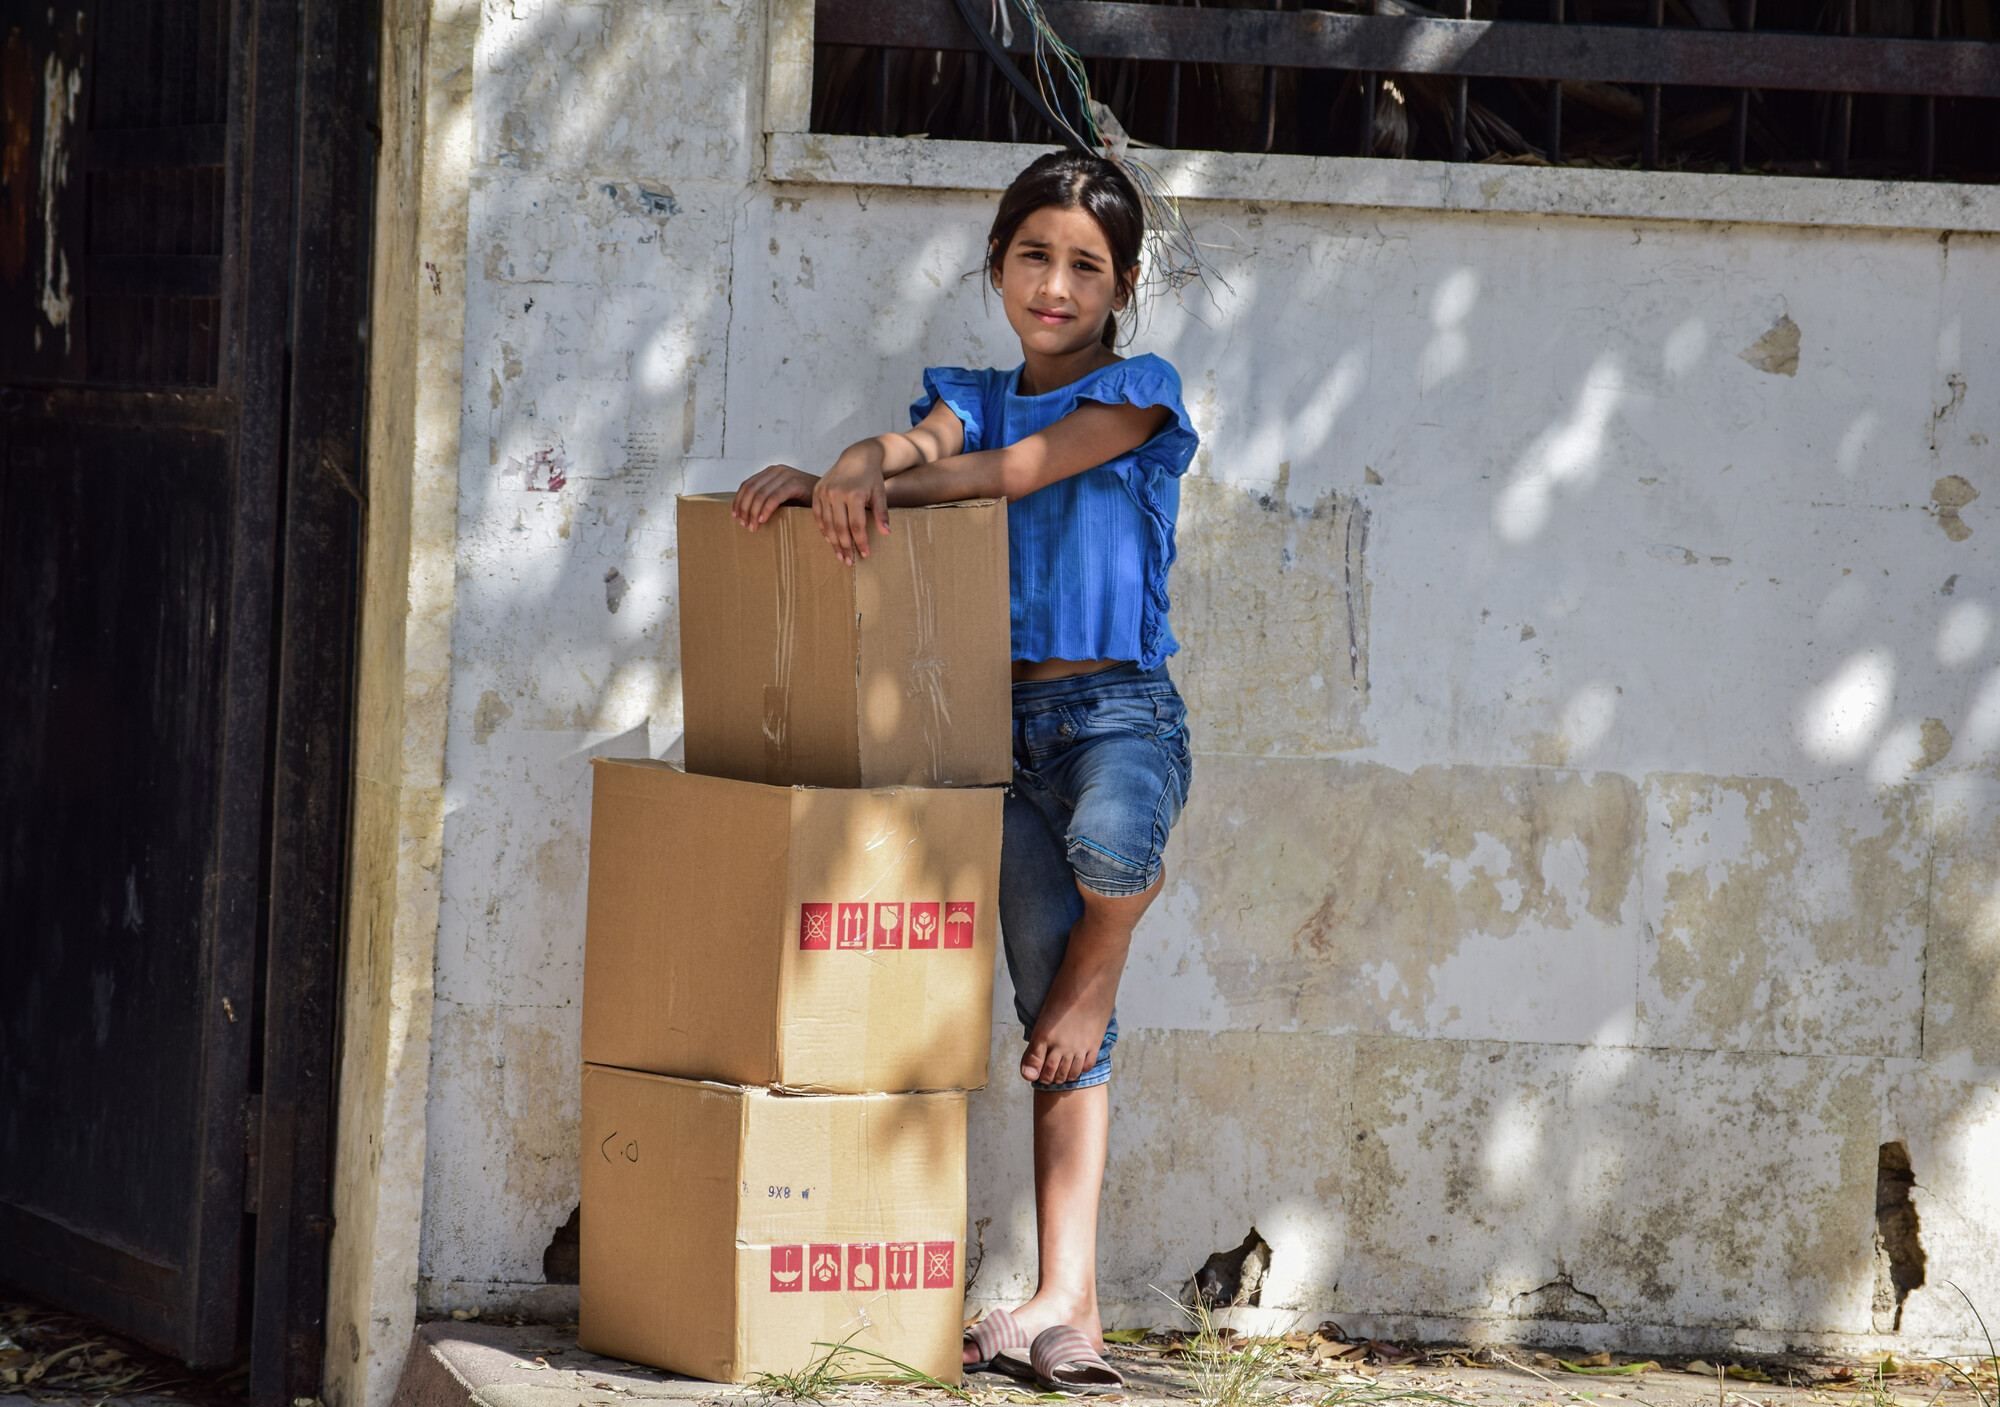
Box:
406 0 2000 1347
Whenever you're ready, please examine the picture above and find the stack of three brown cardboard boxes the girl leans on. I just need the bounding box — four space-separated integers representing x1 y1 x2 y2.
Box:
580 496 1010 1383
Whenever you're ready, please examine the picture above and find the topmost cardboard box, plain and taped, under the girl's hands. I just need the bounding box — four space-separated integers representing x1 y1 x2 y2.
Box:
678 494 1012 787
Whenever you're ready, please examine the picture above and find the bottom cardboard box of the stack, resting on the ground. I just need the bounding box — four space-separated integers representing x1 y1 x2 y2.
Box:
576 1065 966 1383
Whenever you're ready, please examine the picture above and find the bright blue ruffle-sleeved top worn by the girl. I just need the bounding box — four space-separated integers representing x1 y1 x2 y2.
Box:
910 354 1200 670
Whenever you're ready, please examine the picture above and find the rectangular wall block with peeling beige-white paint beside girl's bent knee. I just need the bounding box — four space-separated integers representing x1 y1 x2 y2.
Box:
1168 753 1640 1041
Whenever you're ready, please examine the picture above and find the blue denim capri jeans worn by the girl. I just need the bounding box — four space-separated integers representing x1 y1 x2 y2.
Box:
1000 664 1194 1089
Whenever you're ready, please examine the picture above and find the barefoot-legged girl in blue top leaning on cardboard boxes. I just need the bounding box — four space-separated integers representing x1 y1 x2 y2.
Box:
734 152 1196 1391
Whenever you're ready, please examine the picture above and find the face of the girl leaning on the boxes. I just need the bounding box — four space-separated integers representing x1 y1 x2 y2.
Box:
994 206 1130 356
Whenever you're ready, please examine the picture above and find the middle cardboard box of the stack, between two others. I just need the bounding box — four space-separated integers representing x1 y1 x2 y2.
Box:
584 757 1002 1093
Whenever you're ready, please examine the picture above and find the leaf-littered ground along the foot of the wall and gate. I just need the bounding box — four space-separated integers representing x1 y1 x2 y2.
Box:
0 1301 2000 1407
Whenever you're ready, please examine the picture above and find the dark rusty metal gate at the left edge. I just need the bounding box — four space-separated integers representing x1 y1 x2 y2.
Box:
0 0 376 1403
